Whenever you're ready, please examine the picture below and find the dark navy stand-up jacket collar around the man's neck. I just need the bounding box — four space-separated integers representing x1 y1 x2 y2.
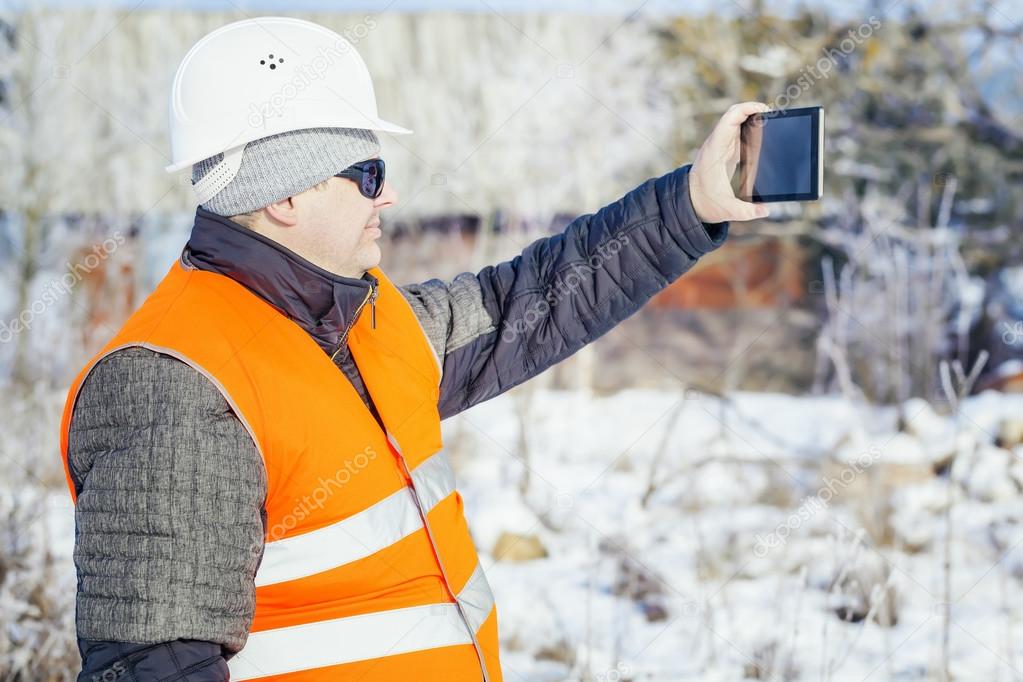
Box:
182 207 376 355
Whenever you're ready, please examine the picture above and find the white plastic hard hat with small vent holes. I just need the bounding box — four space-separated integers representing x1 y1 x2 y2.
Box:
166 16 412 192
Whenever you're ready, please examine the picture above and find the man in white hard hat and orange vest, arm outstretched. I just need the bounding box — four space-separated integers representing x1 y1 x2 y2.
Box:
61 17 766 681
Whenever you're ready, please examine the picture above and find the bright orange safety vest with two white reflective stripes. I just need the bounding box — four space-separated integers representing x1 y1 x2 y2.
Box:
60 262 501 682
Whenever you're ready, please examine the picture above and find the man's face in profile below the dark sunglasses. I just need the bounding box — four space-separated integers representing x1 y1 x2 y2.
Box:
295 160 398 277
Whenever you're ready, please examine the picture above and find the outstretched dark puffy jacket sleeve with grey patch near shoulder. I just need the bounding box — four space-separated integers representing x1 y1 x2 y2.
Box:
402 167 727 417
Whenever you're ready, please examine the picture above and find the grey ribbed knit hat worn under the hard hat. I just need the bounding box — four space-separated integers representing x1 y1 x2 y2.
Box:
192 128 380 217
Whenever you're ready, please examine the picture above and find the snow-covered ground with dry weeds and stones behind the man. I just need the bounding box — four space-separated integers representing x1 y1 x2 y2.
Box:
14 384 1023 682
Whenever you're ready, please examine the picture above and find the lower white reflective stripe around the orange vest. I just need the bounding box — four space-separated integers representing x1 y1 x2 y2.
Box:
228 564 494 680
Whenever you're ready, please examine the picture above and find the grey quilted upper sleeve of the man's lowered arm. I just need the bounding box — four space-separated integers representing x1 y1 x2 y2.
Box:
68 348 266 652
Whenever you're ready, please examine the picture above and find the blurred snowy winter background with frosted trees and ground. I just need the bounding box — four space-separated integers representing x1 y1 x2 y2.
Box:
0 0 1023 682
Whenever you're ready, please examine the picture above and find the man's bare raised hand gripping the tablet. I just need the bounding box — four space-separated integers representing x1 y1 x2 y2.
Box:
690 102 769 223
